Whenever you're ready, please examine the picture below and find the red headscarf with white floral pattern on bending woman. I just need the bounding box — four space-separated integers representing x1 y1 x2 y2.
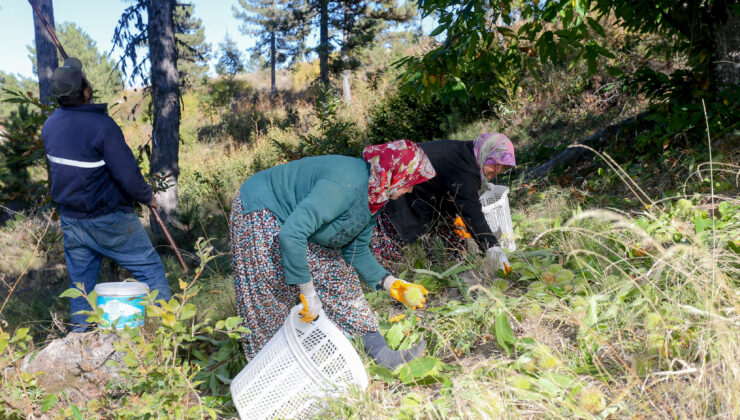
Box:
362 140 437 214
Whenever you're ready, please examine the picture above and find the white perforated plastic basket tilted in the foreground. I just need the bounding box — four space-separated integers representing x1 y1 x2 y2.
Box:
230 305 368 420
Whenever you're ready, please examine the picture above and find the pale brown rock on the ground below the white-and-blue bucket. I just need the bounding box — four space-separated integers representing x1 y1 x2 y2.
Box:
21 331 123 404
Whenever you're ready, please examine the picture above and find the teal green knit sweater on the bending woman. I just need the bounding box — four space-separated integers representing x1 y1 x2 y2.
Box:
239 155 389 289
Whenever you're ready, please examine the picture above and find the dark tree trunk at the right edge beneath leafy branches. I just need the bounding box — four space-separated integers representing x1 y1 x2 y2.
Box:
712 8 740 89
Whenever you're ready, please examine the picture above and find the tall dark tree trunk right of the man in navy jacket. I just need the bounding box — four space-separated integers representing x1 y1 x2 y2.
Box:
147 0 180 226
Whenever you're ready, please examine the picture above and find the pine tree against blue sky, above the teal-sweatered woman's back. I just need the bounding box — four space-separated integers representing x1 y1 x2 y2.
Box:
231 0 308 96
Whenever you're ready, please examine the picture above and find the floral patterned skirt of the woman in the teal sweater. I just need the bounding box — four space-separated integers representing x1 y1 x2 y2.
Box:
229 194 378 360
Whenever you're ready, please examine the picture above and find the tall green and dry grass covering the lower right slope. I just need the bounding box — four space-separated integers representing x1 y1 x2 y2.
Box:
317 186 740 418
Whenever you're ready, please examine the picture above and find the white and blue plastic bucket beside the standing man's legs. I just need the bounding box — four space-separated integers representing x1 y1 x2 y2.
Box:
95 282 149 330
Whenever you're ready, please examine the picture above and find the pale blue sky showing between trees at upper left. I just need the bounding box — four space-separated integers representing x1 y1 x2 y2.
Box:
0 0 254 79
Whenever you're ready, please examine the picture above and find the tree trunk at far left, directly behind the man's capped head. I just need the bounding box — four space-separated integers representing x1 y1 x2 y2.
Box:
31 0 59 104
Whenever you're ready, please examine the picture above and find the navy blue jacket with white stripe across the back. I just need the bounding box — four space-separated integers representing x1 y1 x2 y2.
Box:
41 104 152 219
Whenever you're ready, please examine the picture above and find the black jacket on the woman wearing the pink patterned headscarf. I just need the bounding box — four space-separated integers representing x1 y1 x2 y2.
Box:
385 140 498 249
